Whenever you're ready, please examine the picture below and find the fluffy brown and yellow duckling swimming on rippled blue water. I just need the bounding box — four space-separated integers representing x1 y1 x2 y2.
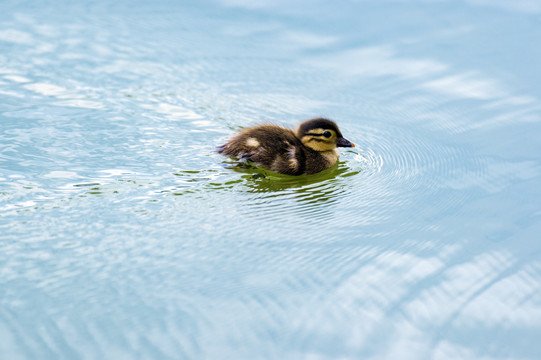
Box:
217 118 355 175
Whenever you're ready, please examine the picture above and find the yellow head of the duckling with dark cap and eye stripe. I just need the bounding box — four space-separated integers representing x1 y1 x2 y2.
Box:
296 118 355 152
